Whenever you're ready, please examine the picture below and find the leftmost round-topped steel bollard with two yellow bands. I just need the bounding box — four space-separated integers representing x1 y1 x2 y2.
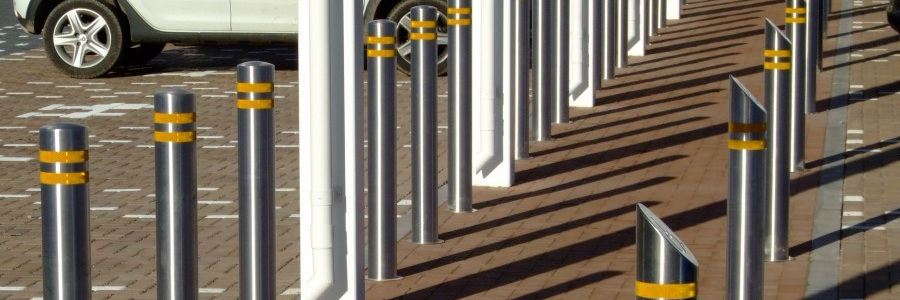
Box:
39 123 91 300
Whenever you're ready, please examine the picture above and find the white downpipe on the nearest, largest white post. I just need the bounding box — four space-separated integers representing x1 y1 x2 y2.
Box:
301 0 335 299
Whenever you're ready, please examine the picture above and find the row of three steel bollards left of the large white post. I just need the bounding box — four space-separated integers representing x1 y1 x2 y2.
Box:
39 62 275 300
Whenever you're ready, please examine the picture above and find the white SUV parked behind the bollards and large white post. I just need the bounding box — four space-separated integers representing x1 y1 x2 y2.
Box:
13 0 447 78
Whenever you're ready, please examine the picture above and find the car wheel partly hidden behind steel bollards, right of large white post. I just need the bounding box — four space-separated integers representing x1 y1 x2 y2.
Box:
387 0 450 75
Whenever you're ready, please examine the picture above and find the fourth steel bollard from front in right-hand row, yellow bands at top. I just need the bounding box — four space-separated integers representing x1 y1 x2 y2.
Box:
785 0 806 172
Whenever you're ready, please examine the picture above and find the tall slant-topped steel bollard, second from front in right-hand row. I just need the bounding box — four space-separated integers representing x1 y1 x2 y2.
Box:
725 77 766 300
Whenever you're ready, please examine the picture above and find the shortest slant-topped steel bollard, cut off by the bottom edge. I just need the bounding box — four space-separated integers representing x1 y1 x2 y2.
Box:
634 203 700 299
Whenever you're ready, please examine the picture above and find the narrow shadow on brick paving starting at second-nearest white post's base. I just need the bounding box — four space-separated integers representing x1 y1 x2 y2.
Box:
516 123 728 180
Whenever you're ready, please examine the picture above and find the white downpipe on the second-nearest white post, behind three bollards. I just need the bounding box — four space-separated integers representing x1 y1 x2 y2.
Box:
473 1 502 172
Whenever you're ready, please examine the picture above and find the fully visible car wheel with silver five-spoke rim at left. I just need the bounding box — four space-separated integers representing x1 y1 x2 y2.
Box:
43 0 126 78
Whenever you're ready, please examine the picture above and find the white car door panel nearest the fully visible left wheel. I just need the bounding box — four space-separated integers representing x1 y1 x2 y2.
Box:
126 0 231 32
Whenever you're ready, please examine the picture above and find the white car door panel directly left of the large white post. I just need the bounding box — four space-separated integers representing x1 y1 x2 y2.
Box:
231 0 304 33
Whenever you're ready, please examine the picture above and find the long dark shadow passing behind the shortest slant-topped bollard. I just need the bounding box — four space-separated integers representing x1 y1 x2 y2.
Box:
400 199 727 299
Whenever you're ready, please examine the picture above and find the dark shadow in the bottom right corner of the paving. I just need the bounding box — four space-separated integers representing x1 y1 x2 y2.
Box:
804 261 900 299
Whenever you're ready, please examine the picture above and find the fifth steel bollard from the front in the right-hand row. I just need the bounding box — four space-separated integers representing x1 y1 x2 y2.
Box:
803 0 822 115
